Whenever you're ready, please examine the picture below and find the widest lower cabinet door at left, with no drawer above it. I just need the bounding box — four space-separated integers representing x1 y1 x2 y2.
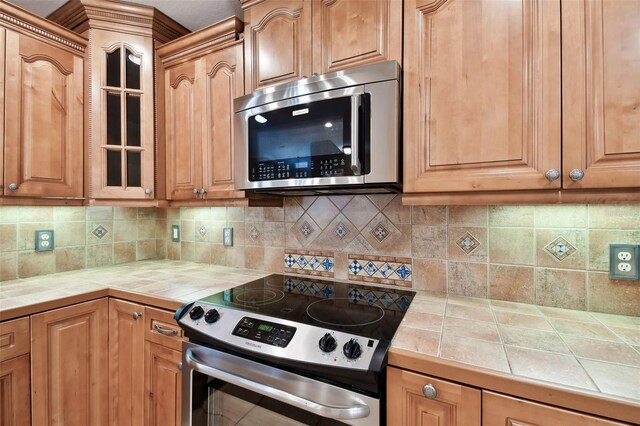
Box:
31 298 109 426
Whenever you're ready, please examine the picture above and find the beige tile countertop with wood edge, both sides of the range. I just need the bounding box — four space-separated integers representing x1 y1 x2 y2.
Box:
0 260 640 422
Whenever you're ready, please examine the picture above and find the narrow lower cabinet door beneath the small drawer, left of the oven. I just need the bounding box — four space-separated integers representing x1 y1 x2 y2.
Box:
145 342 182 426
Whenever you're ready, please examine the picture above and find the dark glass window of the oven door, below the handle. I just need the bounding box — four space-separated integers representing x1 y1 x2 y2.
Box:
202 379 345 426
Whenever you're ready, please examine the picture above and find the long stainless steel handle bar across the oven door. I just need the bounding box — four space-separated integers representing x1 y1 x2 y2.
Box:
184 348 370 420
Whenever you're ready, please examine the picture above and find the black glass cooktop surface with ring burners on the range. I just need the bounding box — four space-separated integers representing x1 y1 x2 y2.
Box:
201 274 414 341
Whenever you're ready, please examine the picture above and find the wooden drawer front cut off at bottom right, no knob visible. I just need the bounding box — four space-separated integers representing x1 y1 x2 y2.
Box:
482 391 626 426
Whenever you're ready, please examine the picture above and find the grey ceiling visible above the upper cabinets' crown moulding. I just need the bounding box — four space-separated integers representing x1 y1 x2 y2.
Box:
10 0 242 31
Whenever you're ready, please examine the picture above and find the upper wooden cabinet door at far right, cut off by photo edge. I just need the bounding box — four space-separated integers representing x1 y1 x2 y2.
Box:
562 0 640 189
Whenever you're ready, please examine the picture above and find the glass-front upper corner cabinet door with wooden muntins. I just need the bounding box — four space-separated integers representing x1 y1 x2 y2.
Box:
90 31 155 199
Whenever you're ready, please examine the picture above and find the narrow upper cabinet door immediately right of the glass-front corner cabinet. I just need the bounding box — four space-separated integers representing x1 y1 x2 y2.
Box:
165 61 202 200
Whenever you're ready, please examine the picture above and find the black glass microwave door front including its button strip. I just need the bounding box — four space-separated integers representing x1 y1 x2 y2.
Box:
248 96 362 182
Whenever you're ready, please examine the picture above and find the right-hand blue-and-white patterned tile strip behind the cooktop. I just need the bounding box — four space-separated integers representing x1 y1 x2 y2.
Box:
348 255 412 287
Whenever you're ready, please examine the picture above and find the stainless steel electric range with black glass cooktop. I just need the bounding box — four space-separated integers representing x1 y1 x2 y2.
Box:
175 274 413 426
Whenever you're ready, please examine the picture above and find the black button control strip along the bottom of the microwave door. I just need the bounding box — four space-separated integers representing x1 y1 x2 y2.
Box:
249 154 353 182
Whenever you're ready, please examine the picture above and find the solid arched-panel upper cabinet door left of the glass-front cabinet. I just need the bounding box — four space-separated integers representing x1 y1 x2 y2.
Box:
4 31 83 197
